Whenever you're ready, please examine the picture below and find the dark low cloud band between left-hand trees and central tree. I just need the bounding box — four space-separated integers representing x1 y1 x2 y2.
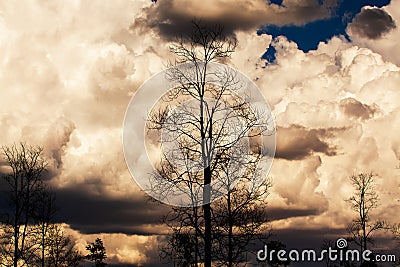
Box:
52 185 169 235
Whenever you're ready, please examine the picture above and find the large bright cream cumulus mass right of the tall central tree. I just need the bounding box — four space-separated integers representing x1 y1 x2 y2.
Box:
251 34 400 236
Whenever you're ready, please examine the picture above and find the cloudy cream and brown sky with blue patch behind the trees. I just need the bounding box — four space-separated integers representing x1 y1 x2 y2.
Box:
0 0 400 266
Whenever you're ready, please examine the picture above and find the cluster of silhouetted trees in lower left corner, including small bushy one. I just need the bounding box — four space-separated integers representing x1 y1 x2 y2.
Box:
0 143 107 267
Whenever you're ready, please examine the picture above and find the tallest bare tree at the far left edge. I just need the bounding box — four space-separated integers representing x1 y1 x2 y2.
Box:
3 143 47 267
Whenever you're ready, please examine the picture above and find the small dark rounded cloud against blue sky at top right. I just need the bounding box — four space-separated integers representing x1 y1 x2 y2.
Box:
349 8 396 39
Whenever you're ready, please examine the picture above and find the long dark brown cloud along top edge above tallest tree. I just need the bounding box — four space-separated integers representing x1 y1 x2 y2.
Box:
132 0 337 39
